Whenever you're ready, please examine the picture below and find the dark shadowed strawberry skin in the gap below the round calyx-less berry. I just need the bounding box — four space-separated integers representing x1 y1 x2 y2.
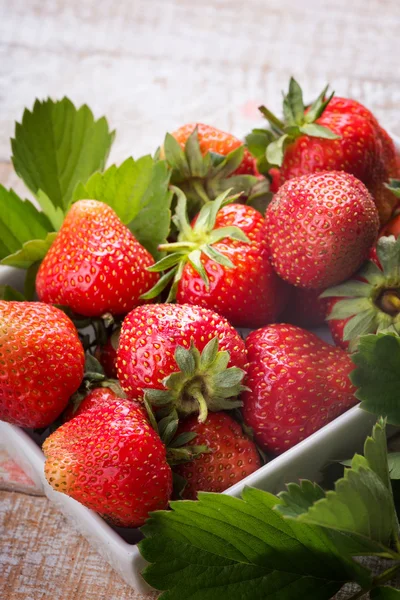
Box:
280 286 327 328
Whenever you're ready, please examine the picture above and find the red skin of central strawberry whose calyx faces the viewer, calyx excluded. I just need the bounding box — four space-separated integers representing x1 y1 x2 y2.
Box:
117 304 247 401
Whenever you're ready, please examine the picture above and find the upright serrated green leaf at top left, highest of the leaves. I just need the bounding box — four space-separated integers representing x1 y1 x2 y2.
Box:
11 98 114 210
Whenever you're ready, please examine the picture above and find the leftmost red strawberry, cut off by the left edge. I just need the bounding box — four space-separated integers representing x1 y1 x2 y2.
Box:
0 301 85 428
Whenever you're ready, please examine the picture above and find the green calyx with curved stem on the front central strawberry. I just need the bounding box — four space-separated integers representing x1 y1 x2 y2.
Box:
144 337 247 423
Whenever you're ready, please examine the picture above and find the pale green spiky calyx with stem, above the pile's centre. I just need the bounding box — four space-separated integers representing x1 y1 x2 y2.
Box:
141 187 250 302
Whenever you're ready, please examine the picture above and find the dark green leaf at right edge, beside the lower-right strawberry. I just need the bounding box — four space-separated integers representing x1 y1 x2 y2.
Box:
350 333 400 425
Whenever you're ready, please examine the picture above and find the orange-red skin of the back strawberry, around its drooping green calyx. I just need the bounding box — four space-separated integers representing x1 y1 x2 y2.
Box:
172 123 258 175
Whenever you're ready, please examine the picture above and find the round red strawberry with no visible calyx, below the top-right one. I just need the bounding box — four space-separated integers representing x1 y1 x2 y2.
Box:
265 171 379 289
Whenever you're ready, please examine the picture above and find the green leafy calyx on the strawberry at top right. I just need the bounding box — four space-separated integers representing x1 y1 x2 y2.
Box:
257 77 340 166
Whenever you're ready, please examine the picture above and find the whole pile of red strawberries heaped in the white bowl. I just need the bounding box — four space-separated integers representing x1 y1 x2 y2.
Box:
0 80 400 527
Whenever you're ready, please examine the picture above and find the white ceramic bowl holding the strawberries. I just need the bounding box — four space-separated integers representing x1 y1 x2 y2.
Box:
0 134 400 593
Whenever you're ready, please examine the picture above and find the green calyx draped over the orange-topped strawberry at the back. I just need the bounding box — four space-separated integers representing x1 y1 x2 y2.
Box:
163 127 269 217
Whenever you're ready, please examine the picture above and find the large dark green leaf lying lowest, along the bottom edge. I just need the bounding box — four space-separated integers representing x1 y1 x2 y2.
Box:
139 488 370 600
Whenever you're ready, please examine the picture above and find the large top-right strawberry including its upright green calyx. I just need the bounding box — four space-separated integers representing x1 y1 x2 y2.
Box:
260 78 397 223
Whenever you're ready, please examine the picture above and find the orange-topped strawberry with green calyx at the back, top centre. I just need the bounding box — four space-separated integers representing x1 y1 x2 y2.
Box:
161 124 269 218
